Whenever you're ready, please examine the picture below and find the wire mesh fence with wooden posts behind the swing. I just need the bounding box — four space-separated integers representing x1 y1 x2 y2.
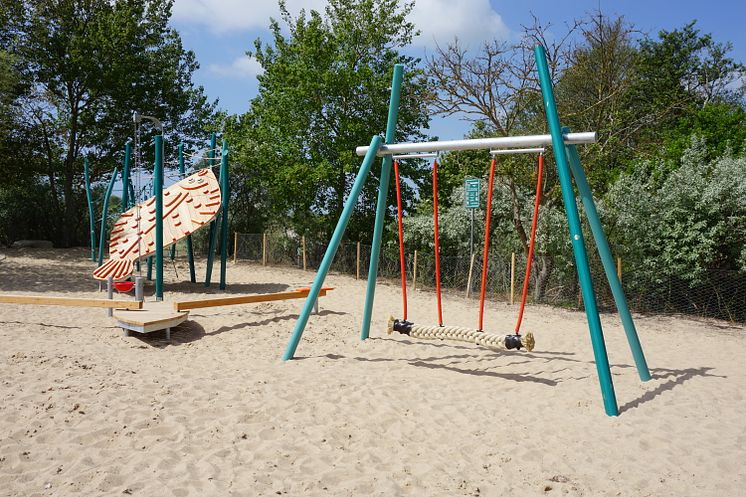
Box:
232 233 746 322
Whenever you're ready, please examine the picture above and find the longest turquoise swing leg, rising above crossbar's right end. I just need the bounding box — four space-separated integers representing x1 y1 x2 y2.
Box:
534 45 619 416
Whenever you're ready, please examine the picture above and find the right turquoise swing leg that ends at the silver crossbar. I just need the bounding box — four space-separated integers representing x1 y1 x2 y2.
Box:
563 136 650 381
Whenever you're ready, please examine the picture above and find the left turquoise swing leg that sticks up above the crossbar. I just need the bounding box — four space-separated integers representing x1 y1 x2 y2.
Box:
360 64 404 340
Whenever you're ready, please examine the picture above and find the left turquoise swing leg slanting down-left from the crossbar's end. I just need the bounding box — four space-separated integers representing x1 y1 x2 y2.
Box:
282 136 381 361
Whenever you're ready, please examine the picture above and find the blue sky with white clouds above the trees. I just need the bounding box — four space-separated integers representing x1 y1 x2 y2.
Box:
172 0 746 139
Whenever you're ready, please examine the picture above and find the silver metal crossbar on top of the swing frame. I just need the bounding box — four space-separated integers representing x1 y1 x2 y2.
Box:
355 131 596 157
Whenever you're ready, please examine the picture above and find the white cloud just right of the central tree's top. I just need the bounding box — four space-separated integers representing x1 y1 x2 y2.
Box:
410 0 510 48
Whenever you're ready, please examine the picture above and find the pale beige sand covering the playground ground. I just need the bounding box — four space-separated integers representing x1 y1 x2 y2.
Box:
0 249 746 497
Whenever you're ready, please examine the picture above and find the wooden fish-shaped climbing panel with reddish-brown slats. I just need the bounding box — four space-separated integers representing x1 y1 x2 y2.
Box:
93 169 221 281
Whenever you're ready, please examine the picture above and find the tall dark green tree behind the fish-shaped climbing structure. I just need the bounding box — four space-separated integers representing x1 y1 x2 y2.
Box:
9 0 213 245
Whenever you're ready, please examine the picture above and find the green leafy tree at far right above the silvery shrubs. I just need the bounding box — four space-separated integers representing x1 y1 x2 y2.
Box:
625 22 746 165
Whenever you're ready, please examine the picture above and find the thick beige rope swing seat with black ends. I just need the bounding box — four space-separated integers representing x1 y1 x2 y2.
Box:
387 316 536 352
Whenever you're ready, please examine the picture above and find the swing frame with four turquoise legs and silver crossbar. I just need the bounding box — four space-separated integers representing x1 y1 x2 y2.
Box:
283 46 650 416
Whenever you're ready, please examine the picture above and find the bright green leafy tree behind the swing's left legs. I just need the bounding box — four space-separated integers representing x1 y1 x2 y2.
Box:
228 0 428 239
